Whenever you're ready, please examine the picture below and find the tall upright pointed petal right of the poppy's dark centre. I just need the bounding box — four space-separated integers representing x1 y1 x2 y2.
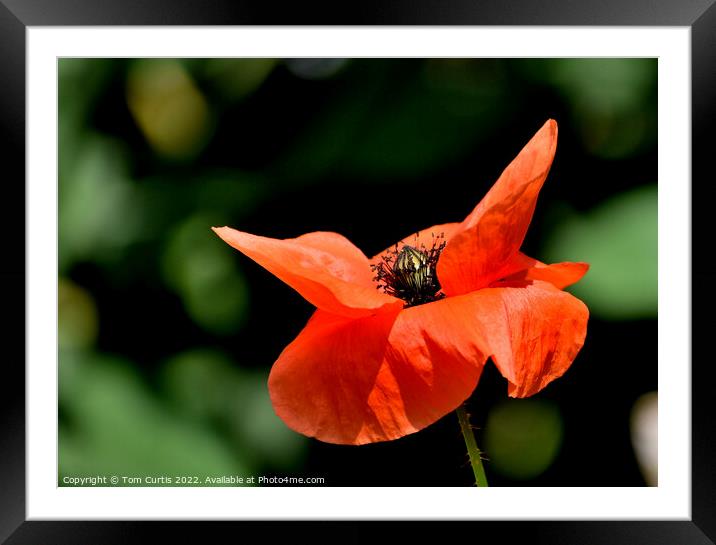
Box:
437 119 557 295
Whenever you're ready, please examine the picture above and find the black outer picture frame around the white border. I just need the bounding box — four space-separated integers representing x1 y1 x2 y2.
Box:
0 0 716 545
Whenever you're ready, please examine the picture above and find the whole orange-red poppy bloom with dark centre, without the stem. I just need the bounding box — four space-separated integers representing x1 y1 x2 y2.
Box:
214 120 589 444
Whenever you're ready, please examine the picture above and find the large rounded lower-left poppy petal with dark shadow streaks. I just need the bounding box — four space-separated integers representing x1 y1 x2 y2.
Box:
269 299 486 444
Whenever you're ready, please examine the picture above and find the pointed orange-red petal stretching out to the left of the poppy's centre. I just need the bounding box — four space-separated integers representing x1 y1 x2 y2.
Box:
213 227 403 317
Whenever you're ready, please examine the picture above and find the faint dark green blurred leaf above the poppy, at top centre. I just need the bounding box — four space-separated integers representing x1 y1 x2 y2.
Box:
280 59 509 183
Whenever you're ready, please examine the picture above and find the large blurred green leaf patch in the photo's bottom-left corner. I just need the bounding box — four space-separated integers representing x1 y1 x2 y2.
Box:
59 351 249 484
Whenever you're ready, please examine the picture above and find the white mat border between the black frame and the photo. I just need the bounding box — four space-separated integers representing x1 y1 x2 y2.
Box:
27 27 691 520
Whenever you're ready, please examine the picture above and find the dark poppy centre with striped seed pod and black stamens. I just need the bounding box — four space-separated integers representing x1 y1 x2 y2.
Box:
371 233 446 307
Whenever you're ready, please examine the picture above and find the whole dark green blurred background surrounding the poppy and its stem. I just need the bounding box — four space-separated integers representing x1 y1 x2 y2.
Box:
58 59 657 486
